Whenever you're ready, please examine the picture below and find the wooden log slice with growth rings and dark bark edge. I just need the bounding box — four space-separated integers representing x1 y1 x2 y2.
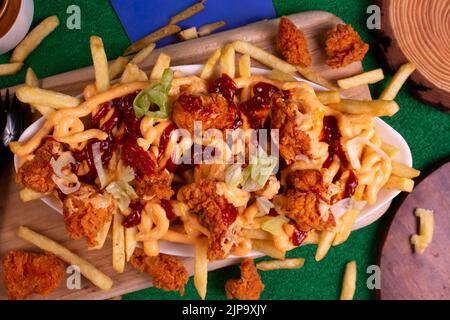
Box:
377 0 450 111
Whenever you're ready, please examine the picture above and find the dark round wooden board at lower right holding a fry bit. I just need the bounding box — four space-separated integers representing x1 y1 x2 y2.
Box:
378 161 450 300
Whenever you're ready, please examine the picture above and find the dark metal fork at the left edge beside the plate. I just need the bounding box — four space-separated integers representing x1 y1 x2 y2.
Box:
0 90 26 171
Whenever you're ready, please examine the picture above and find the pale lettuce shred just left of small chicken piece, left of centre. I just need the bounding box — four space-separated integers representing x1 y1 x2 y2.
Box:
106 167 138 211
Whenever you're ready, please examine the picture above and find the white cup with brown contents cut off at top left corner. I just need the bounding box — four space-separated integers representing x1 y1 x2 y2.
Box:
0 0 34 54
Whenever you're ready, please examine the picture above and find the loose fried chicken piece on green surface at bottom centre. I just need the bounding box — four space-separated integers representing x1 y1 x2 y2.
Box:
225 258 264 300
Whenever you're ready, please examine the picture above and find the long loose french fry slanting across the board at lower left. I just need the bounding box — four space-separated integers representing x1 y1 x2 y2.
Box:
17 226 113 291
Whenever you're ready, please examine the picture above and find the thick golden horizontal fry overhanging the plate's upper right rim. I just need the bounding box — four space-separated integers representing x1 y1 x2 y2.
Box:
328 99 400 117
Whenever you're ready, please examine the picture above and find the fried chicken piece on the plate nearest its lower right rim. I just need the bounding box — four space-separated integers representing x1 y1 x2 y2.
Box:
274 189 336 231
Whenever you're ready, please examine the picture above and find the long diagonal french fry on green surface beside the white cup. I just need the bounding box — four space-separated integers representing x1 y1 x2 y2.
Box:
11 16 59 62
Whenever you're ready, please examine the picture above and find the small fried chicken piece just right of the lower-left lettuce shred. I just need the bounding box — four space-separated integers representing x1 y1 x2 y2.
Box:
134 171 174 200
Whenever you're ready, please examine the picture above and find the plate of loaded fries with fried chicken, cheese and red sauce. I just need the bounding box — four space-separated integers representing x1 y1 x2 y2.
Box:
7 14 418 297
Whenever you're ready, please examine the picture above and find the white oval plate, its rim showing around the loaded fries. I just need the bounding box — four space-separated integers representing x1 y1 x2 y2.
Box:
14 64 412 257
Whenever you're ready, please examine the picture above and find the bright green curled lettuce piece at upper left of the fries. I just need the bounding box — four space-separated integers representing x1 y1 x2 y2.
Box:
133 68 173 119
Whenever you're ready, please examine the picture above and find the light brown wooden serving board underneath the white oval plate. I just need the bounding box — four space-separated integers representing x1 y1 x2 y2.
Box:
0 11 370 299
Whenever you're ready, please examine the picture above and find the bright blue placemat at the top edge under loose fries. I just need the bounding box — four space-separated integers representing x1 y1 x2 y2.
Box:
111 0 275 46
